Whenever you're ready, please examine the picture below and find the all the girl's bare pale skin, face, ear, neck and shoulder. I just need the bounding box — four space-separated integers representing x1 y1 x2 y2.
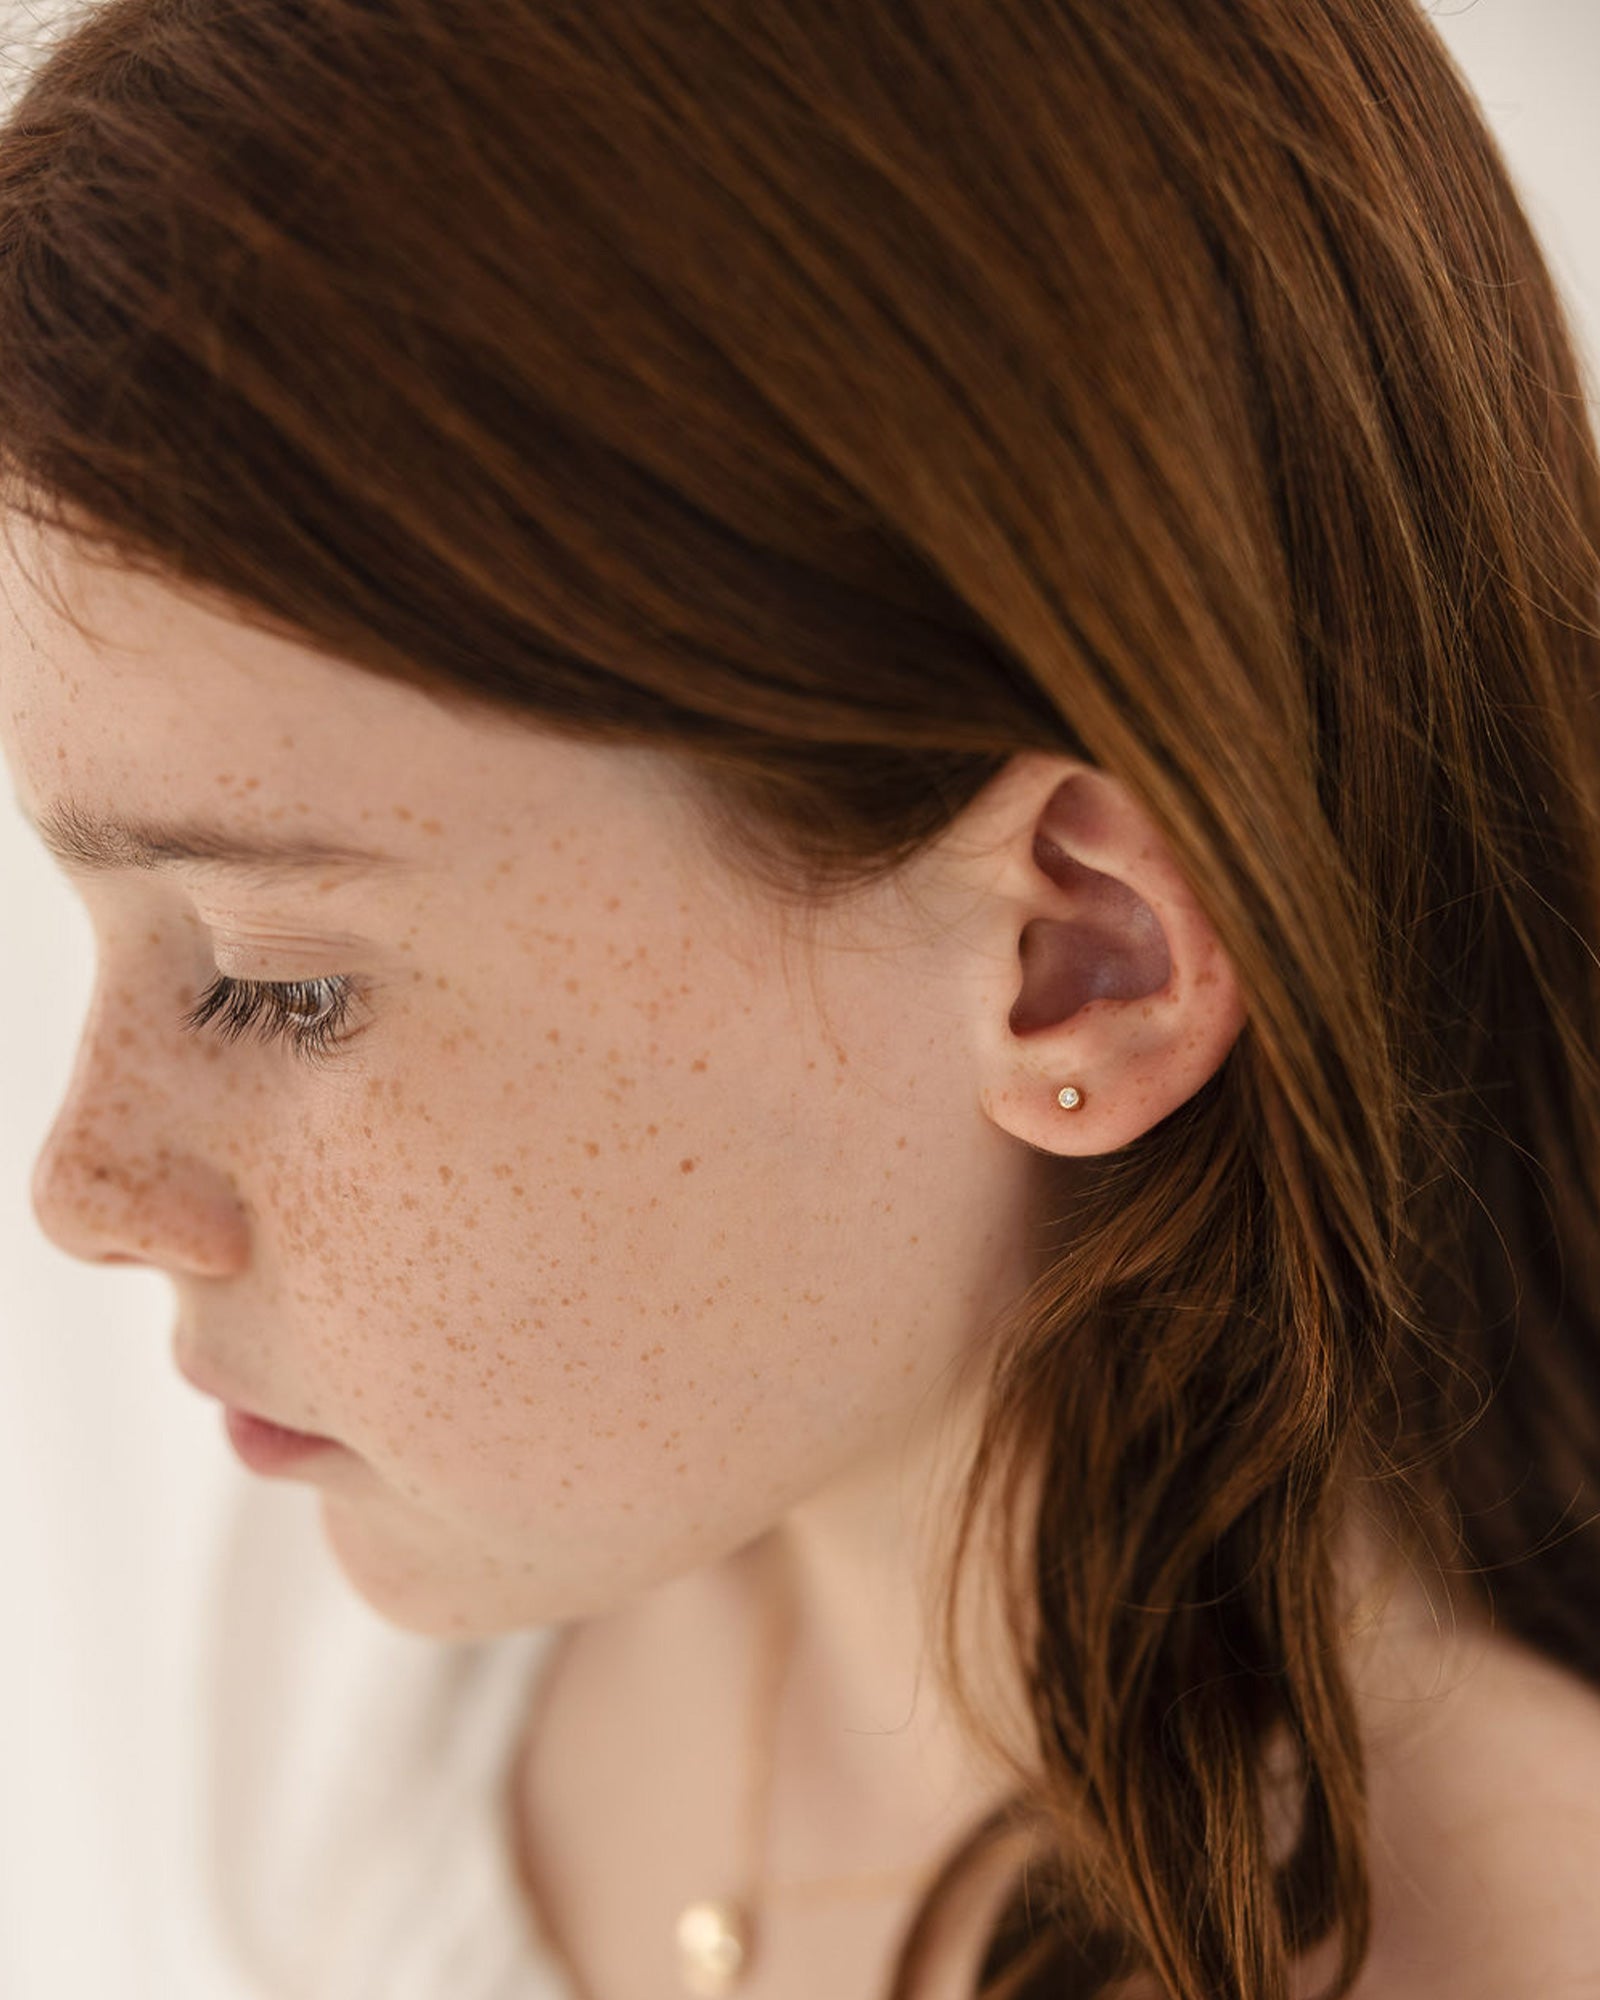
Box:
0 520 1600 2000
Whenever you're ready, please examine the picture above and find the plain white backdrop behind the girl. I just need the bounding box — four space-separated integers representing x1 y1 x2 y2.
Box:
0 0 1600 2000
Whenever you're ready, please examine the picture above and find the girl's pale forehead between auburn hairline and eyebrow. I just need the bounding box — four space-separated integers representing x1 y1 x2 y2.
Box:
0 532 712 896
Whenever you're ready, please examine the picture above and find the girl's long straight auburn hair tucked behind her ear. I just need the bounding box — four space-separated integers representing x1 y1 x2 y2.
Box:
0 0 1600 2000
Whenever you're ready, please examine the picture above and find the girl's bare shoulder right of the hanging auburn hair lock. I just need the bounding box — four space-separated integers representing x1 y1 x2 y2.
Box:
1350 1632 1600 2000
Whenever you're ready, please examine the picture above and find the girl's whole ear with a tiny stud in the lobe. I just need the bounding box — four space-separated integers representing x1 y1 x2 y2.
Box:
950 752 1246 1154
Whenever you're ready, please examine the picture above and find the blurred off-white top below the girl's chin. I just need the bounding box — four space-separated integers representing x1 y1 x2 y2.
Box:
200 1480 570 2000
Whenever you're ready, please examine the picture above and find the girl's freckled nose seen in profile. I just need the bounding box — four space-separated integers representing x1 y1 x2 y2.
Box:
30 1008 248 1276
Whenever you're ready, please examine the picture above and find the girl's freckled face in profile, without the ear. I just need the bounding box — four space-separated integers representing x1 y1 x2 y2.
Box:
0 550 1038 1636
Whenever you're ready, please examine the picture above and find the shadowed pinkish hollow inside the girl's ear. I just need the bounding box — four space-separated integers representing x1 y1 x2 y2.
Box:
1010 834 1172 1034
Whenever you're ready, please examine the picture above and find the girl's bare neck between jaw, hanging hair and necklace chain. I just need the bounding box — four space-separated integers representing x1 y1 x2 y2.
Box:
644 1344 1026 1884
